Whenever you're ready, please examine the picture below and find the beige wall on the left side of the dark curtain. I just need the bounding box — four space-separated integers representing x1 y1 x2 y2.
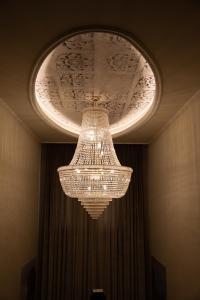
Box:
0 100 40 300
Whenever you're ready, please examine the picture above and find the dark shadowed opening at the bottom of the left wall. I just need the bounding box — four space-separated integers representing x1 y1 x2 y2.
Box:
21 258 36 300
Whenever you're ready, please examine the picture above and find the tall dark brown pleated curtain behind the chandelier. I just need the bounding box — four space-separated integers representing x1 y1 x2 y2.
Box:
36 144 150 300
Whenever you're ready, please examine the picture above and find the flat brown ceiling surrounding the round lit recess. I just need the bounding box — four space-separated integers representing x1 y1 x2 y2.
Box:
0 0 200 143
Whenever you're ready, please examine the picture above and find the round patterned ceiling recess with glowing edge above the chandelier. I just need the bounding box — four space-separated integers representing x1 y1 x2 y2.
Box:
31 30 160 136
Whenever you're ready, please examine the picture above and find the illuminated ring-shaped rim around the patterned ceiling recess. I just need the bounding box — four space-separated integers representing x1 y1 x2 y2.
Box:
29 28 161 137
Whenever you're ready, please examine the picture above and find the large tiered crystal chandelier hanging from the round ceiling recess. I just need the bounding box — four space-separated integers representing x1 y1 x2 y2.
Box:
58 107 132 219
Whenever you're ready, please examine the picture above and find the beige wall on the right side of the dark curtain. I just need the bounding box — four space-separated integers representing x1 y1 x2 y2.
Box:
149 94 200 300
